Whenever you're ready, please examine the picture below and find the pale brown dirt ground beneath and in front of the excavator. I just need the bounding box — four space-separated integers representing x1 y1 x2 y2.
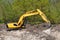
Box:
0 24 60 40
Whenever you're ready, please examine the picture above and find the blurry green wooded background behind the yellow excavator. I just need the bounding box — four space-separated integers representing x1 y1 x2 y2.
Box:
0 0 60 24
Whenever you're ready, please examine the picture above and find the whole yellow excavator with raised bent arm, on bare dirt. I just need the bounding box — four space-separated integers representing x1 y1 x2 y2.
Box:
7 9 50 29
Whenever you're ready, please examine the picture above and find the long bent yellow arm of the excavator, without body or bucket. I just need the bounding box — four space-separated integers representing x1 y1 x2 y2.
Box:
18 9 50 25
